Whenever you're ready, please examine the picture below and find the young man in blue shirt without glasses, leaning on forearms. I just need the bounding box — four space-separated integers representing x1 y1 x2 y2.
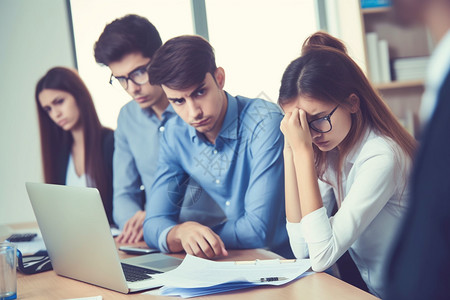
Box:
144 36 292 258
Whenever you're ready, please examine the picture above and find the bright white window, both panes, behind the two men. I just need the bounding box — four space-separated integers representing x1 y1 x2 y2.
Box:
70 0 318 128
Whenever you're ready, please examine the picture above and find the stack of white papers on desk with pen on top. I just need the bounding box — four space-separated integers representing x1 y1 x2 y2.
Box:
152 255 313 298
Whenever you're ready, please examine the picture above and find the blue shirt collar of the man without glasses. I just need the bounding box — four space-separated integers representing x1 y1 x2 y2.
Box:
188 92 239 142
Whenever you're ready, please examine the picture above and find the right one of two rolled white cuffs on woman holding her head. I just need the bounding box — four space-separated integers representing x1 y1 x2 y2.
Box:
300 207 332 244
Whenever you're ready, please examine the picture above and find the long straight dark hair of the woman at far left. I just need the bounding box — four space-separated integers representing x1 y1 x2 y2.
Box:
35 67 112 214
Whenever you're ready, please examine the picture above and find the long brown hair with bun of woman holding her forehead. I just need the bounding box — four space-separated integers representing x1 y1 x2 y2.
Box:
278 32 416 202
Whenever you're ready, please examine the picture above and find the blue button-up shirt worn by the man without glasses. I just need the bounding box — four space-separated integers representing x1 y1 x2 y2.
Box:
144 94 292 257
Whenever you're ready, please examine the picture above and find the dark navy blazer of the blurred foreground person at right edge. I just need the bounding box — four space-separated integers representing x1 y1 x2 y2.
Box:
386 72 450 300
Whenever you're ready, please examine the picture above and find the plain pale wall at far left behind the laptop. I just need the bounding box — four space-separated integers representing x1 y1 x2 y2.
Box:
0 0 74 225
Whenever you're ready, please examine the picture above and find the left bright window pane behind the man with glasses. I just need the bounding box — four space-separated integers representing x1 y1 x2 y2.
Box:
70 0 194 129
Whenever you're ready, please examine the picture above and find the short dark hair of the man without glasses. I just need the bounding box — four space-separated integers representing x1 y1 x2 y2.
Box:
148 35 217 90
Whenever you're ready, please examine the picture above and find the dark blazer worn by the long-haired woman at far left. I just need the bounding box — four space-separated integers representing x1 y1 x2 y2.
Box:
55 128 114 224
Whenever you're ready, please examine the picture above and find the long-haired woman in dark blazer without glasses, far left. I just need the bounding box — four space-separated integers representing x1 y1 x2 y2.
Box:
35 67 114 224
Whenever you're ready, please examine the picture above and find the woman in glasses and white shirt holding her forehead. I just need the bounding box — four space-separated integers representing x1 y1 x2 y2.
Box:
278 32 416 297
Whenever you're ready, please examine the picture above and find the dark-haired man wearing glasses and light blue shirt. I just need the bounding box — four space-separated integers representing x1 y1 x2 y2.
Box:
94 15 175 243
